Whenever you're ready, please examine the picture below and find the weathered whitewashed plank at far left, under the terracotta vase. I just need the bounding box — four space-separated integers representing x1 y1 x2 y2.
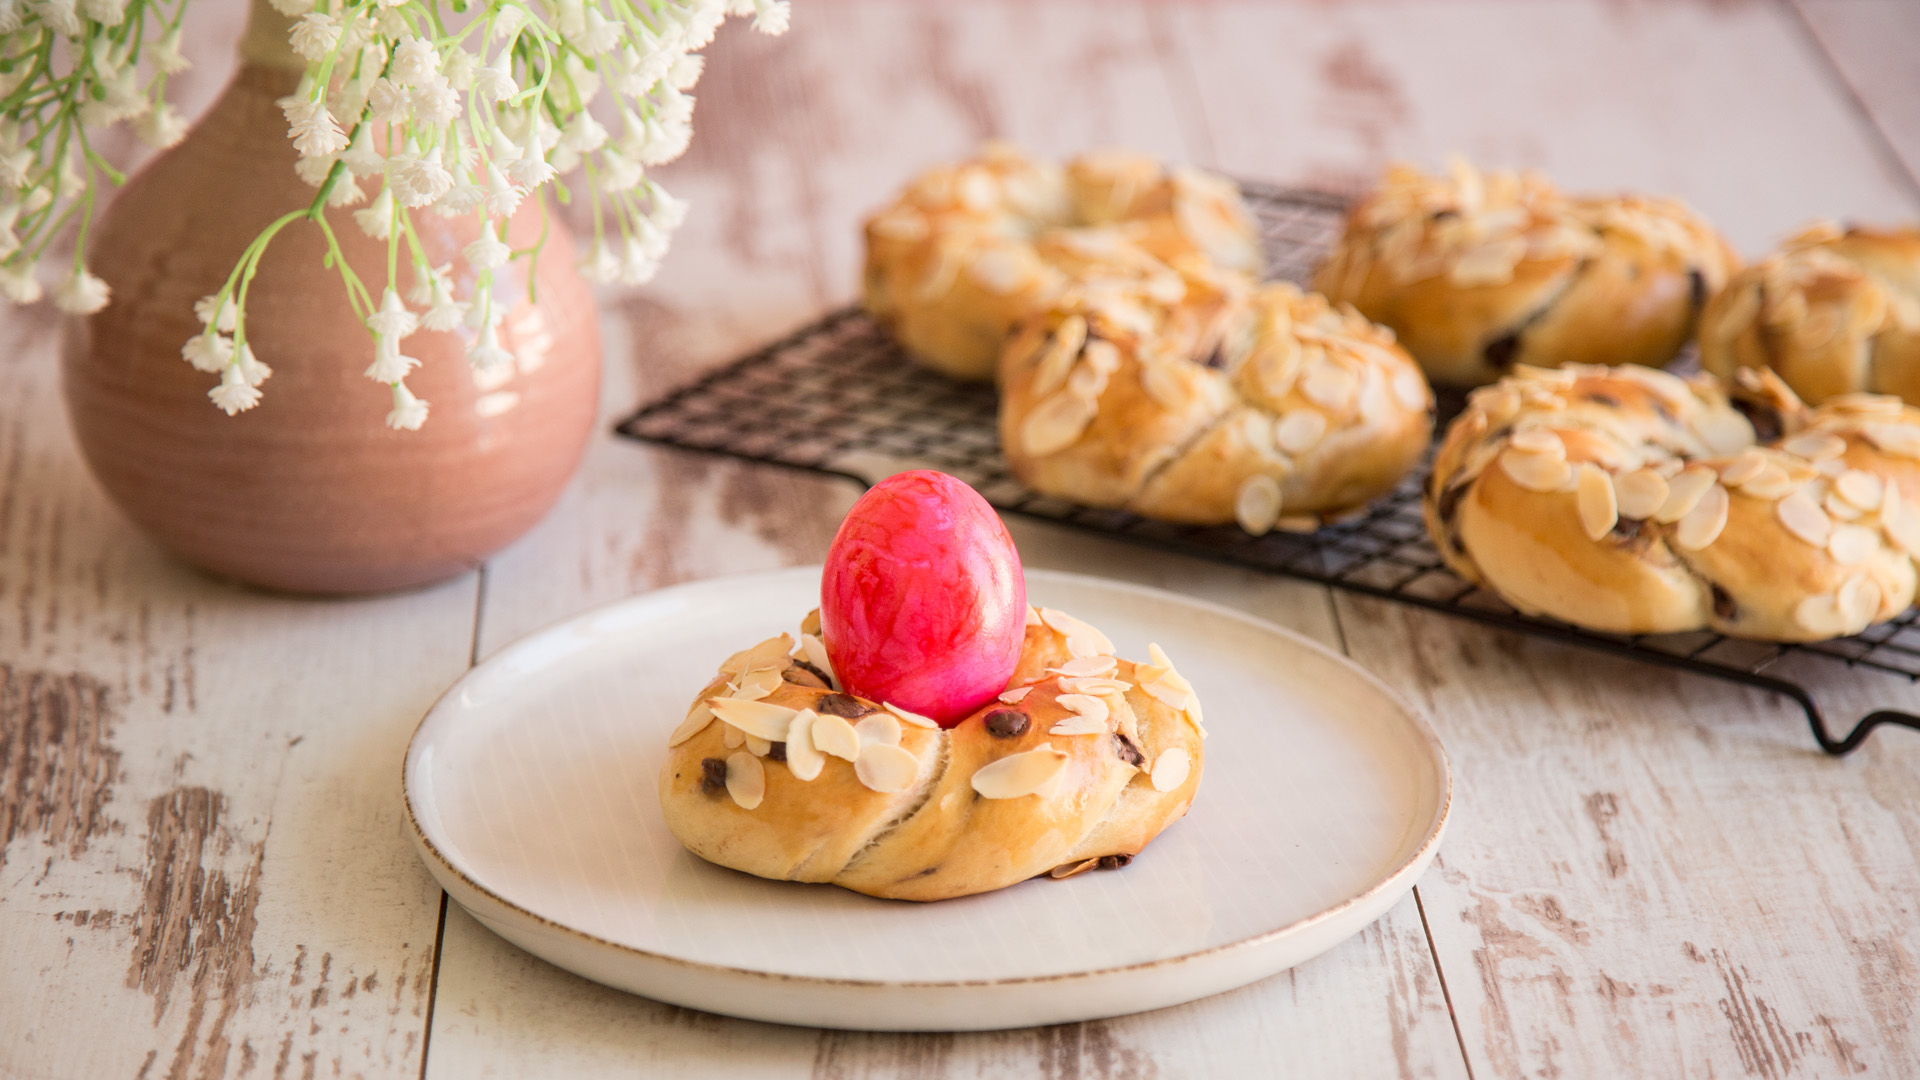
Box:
0 0 476 1080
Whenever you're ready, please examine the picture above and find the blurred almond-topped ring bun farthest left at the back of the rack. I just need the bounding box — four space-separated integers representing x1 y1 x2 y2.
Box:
864 144 1261 380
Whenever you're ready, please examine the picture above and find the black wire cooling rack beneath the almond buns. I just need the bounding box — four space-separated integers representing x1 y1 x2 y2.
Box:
618 183 1920 755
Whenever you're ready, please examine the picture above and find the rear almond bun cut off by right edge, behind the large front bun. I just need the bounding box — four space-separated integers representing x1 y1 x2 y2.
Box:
1699 223 1920 404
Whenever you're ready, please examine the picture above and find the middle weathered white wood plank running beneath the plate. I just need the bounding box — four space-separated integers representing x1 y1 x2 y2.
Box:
428 4 1461 1078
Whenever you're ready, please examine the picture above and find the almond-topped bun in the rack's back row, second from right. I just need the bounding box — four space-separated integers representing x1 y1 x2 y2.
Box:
1313 160 1740 386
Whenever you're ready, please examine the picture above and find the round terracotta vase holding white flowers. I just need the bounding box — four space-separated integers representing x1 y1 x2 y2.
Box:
63 0 599 592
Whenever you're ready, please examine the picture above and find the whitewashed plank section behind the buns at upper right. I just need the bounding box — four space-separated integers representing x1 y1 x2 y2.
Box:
1169 0 1912 254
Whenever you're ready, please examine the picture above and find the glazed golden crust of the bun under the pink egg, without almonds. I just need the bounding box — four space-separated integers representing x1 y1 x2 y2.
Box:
660 613 1204 899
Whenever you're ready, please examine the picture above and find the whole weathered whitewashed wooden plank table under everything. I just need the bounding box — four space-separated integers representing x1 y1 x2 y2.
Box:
0 0 1920 1080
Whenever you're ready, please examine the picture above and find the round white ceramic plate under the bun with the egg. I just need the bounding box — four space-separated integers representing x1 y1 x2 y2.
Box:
405 567 1452 1030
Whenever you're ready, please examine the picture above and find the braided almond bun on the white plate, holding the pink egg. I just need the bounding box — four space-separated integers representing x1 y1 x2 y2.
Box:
660 609 1204 899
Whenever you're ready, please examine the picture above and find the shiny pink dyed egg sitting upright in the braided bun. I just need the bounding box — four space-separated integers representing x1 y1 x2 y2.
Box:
820 469 1027 726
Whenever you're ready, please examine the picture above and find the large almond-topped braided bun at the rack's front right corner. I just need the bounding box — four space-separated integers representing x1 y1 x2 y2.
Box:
1425 367 1920 642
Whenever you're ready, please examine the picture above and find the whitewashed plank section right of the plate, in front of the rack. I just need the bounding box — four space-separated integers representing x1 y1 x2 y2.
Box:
1336 598 1920 1076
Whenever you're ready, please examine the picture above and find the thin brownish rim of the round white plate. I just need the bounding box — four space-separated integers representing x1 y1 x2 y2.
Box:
399 563 1453 990
